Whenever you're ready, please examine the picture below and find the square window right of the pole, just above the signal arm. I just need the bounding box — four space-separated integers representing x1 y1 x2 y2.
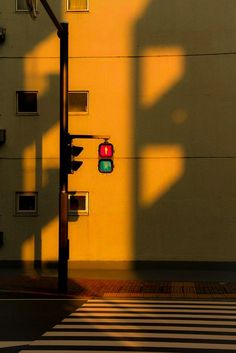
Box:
68 91 88 114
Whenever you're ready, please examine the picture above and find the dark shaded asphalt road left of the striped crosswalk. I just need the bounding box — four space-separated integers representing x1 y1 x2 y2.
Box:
0 298 85 353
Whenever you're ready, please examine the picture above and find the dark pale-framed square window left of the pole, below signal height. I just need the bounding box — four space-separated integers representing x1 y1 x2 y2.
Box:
16 192 38 216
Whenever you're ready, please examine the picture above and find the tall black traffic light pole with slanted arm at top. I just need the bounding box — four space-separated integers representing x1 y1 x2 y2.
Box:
36 0 69 293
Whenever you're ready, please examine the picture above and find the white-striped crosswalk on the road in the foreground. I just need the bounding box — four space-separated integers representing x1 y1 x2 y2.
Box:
20 299 236 353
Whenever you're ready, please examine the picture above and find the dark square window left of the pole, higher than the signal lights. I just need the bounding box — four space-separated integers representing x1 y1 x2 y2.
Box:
16 91 38 115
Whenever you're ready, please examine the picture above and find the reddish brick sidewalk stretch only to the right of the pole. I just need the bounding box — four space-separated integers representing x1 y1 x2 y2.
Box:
70 280 236 299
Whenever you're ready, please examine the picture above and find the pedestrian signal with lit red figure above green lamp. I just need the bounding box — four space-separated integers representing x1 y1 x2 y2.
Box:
98 142 114 173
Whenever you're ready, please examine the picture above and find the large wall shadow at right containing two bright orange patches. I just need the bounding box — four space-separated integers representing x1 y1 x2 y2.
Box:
134 0 236 261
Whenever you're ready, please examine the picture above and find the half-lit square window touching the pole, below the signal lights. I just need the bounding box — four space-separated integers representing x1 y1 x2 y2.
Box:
68 191 88 216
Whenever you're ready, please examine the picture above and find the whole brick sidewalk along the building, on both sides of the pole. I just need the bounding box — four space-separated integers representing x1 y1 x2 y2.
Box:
0 275 236 299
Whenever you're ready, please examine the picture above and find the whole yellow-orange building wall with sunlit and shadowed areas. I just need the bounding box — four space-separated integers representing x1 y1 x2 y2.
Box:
0 0 236 266
